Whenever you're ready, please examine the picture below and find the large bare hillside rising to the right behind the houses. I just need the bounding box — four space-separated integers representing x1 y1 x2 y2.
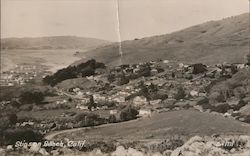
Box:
77 13 250 65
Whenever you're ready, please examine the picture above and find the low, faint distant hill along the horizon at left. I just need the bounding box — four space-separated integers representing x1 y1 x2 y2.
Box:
1 36 110 50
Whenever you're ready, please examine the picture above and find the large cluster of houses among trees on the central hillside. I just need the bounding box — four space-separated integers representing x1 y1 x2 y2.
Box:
52 60 248 120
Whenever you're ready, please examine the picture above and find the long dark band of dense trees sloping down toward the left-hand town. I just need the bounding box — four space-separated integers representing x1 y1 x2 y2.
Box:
43 59 105 86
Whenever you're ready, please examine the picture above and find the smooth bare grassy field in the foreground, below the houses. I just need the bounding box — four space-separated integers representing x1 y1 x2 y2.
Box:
55 110 250 141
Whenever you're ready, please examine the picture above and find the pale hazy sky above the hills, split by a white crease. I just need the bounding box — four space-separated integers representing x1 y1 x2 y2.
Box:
1 0 249 41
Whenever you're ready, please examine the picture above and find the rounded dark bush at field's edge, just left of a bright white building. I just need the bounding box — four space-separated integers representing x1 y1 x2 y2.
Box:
120 105 139 121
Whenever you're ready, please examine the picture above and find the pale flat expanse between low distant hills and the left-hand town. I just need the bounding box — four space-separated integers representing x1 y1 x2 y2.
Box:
1 49 84 72
